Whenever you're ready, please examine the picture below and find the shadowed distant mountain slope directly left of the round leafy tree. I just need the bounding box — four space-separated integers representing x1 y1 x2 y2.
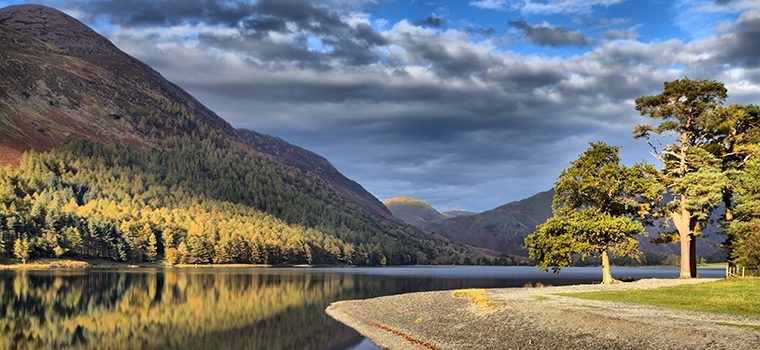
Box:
424 191 554 256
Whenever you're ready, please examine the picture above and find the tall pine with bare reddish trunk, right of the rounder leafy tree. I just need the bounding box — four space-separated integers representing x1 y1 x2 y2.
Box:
633 78 728 278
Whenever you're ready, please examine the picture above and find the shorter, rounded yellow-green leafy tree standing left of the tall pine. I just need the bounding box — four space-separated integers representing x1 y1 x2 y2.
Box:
525 142 660 284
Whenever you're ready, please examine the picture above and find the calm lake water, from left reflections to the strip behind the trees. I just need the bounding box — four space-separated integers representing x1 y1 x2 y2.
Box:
0 266 724 349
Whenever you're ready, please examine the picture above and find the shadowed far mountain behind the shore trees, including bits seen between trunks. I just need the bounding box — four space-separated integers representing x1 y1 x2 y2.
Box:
422 190 724 258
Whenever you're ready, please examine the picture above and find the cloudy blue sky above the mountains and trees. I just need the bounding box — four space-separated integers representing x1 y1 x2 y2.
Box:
0 0 760 211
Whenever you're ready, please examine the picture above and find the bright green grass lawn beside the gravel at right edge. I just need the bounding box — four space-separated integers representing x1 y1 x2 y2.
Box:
559 278 760 317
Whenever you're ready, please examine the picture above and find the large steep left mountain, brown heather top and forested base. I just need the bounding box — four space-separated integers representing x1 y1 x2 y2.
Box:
0 5 473 264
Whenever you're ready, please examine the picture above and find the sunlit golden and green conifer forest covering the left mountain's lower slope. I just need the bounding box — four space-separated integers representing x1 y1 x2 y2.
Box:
0 135 472 265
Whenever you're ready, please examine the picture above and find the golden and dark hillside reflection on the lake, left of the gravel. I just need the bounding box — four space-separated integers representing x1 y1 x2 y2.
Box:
0 272 374 349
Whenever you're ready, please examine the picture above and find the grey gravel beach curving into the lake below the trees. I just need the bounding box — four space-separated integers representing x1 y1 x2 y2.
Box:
327 279 760 349
